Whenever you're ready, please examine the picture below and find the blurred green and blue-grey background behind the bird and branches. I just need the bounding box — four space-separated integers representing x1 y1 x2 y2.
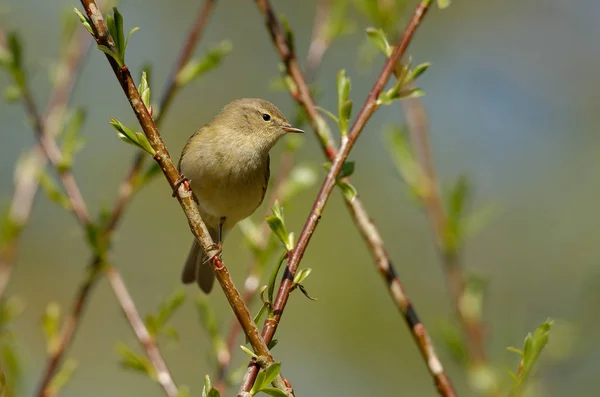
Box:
0 0 600 397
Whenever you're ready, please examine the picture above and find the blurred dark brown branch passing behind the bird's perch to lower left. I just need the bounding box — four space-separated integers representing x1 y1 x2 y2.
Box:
39 0 216 397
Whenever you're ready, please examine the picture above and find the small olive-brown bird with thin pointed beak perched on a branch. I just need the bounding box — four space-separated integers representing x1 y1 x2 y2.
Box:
179 98 304 293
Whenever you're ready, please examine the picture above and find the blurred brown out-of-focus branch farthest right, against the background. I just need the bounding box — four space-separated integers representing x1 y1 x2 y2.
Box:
403 99 487 367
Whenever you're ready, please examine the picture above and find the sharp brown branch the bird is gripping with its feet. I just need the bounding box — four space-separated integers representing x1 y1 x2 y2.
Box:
81 0 292 394
